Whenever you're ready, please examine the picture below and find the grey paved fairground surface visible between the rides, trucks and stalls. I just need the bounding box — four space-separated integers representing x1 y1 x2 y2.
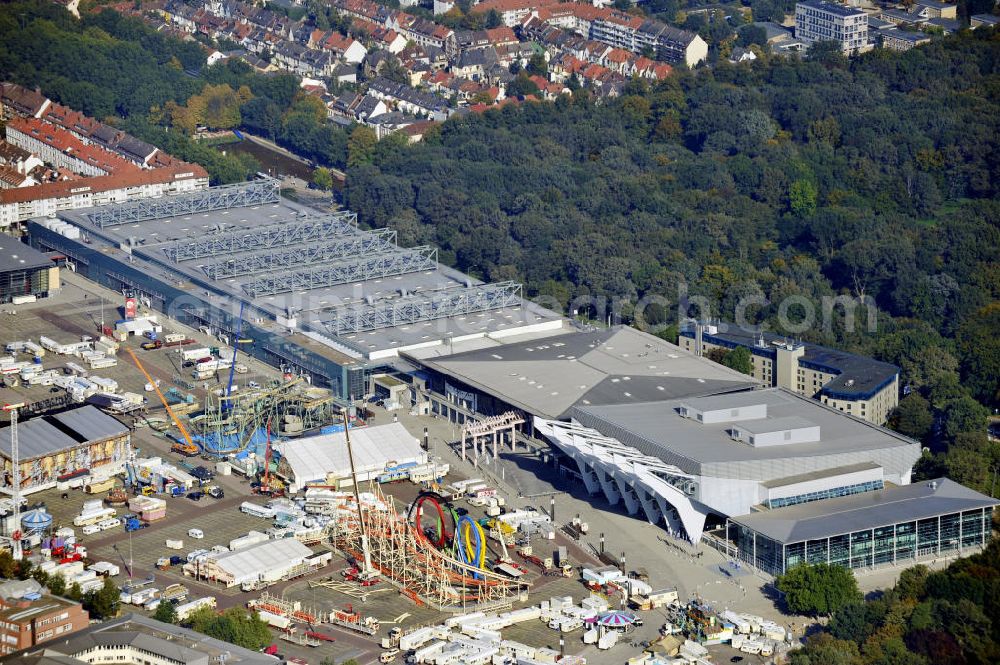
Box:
0 273 945 665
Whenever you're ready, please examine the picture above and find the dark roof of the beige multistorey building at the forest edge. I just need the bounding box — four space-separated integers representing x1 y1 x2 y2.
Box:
680 323 899 399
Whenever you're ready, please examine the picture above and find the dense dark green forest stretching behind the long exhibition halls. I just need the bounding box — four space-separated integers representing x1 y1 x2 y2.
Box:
0 2 1000 494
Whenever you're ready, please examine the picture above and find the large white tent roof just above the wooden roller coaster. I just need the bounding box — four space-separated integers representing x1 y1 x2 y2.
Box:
277 423 427 491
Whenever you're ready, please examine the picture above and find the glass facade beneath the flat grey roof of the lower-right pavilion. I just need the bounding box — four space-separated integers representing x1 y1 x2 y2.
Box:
727 508 993 576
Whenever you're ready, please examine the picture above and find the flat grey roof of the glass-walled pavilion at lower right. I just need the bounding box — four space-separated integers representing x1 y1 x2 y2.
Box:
731 478 1000 544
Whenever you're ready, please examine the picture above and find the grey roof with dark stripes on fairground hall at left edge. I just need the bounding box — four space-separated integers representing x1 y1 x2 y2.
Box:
0 405 128 459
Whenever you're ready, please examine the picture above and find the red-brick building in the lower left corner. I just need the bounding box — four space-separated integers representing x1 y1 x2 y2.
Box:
0 579 90 662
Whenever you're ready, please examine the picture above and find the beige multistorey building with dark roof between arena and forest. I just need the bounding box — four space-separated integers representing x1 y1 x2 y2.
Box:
677 324 899 425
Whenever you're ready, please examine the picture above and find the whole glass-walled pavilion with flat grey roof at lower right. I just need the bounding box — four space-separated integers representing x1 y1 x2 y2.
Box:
726 478 1000 576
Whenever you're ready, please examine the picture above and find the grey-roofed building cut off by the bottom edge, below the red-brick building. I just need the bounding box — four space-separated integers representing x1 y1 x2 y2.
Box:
4 614 282 665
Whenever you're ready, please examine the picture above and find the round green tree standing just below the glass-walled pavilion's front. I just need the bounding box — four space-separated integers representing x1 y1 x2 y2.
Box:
775 563 861 616
